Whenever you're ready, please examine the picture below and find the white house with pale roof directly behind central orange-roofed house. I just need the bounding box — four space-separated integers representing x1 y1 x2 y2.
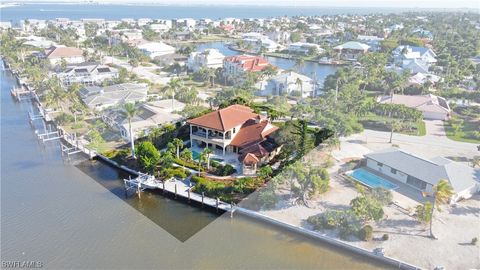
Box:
258 71 317 98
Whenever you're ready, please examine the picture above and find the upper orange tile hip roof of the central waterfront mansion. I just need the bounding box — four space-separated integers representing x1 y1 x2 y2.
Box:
187 105 258 132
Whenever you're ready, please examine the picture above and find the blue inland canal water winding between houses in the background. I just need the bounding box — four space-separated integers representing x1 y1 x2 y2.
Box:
197 41 338 84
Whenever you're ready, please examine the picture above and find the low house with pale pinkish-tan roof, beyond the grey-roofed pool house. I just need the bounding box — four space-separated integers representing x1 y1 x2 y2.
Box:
377 94 451 120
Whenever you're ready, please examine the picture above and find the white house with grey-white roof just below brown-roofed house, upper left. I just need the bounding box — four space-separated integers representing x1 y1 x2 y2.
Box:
57 62 118 86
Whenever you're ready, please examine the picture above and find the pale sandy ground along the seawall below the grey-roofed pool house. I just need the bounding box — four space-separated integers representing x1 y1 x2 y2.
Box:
261 173 480 269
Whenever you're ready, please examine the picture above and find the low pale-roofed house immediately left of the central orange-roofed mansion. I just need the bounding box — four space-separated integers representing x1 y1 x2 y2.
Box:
102 100 185 140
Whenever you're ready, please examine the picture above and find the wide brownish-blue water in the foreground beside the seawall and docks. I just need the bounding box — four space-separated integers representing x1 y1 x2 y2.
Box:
0 63 386 269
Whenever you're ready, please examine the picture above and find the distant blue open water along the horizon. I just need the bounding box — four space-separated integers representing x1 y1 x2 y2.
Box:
0 2 420 21
